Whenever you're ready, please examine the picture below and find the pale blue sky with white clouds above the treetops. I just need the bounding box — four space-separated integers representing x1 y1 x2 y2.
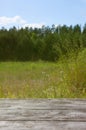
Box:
0 0 86 28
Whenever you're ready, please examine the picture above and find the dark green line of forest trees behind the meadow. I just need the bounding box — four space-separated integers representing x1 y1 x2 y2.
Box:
0 24 86 61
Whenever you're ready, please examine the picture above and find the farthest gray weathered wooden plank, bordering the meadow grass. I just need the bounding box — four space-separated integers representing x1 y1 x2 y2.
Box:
0 99 86 110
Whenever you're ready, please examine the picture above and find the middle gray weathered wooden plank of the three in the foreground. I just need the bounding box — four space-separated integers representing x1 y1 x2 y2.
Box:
0 109 86 122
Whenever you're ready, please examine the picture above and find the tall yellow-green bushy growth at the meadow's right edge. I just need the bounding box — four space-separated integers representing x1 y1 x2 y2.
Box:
67 49 86 97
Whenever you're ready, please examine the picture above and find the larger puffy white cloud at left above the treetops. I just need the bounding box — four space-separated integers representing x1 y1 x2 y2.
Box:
0 16 27 26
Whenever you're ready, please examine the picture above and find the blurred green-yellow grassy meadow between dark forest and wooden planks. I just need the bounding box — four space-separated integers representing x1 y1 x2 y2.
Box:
0 49 86 98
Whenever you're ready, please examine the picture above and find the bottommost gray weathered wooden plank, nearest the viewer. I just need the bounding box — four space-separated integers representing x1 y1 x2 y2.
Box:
0 121 86 130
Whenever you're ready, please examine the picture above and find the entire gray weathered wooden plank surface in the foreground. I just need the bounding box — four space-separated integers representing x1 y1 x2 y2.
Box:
0 99 86 130
